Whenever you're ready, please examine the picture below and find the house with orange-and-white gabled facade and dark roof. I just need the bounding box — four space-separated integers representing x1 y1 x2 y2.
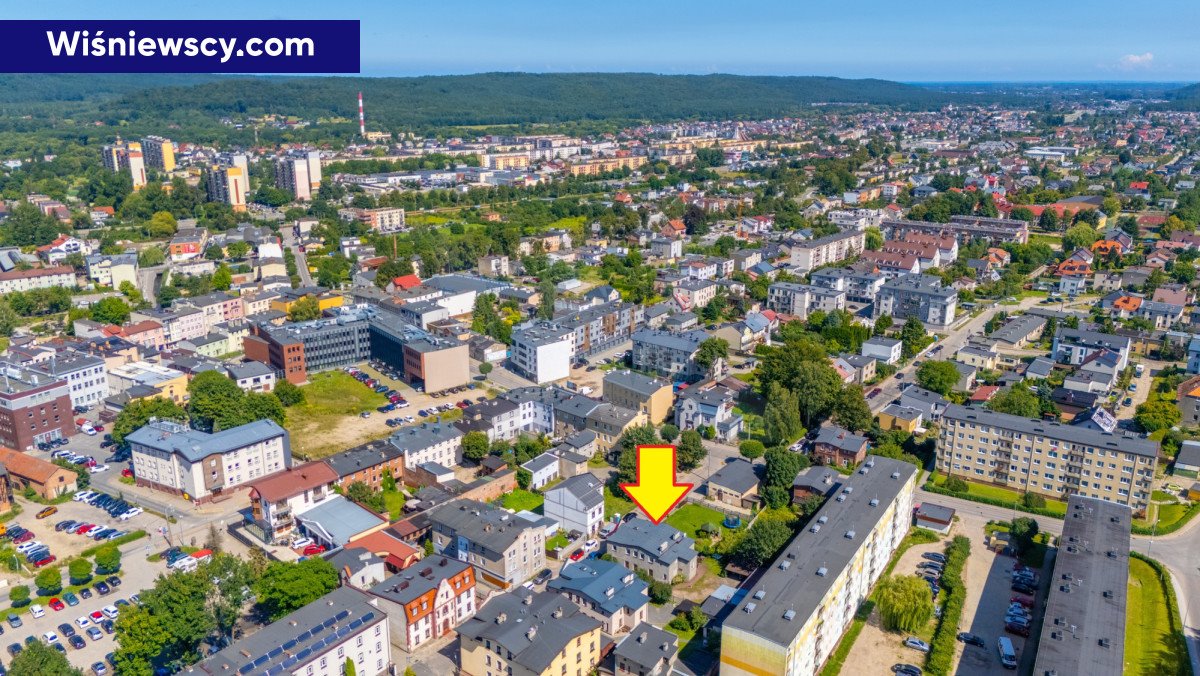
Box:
370 556 478 652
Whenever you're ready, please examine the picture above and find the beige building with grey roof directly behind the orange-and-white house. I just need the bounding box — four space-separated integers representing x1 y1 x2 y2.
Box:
428 499 546 590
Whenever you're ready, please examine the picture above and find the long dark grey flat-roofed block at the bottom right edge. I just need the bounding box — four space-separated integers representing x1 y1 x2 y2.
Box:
1033 496 1133 676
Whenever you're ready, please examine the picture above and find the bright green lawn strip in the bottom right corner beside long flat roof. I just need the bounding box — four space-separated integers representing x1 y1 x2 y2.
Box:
1124 557 1192 676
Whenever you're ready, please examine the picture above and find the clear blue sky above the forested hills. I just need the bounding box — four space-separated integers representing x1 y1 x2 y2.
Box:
16 0 1200 82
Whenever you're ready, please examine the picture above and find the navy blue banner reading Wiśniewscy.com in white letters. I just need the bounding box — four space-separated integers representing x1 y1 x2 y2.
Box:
0 20 359 73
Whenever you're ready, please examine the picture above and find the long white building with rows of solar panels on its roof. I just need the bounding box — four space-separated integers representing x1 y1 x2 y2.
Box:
192 586 391 676
